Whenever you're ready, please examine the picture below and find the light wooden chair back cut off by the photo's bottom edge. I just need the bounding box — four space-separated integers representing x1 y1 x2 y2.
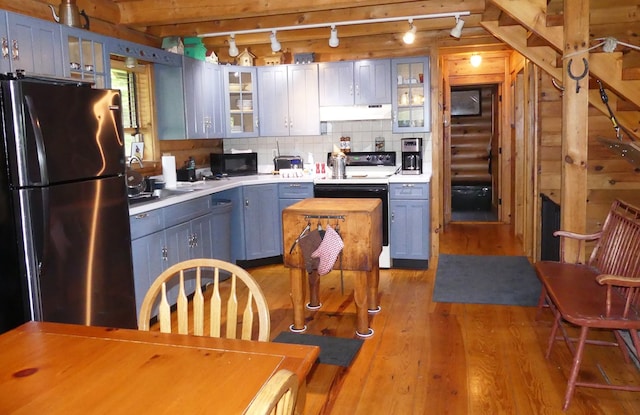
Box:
246 369 298 415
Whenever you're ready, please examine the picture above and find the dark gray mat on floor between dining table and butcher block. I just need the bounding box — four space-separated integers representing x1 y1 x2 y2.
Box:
273 331 364 367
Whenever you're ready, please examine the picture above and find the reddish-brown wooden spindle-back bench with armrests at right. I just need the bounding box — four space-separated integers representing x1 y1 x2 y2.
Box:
535 200 640 409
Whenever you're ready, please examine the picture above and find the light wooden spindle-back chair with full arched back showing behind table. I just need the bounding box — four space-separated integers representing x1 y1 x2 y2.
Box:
138 258 271 341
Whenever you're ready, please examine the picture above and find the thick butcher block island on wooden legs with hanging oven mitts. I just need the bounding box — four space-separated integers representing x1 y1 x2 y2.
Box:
282 198 382 337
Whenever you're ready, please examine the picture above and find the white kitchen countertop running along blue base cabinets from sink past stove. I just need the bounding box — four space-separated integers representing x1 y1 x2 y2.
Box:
129 174 431 216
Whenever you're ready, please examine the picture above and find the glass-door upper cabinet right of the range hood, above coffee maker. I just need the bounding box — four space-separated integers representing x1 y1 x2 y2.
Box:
391 57 431 133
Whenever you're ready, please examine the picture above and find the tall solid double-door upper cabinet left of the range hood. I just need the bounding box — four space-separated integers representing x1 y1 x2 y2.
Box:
258 64 320 136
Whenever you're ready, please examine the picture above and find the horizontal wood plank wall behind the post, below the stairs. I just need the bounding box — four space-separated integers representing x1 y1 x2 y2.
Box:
538 72 640 240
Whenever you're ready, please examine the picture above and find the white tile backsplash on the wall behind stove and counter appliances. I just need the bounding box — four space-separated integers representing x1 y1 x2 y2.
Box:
223 120 431 173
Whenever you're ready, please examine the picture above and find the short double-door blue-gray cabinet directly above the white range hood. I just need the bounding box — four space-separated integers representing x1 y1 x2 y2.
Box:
318 59 391 107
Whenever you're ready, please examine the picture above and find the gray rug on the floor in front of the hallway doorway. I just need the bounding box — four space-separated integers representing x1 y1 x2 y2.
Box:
433 254 541 306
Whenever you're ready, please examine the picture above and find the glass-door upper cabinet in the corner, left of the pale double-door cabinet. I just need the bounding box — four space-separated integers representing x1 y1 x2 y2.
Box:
224 66 258 138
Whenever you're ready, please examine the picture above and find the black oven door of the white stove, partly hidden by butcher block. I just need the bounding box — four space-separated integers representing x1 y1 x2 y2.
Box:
313 183 389 246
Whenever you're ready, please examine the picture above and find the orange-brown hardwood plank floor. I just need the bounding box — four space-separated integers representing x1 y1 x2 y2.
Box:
250 224 640 415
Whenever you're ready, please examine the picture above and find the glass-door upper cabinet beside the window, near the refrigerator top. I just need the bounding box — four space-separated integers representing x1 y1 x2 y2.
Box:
62 26 111 88
